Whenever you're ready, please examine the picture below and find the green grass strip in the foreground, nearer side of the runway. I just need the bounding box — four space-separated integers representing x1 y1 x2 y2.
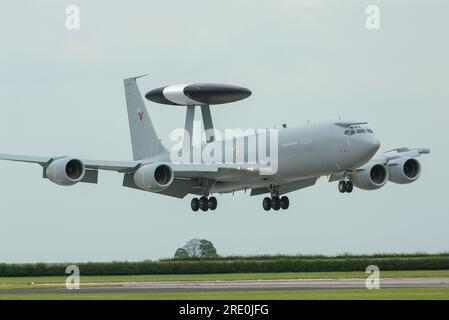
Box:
0 288 449 300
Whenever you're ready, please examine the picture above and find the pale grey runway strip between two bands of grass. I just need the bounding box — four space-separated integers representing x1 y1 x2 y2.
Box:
0 278 449 295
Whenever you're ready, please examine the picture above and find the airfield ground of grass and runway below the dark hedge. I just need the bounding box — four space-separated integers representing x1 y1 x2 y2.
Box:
0 270 449 300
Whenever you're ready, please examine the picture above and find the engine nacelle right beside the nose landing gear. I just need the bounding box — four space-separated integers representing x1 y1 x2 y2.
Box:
351 163 388 190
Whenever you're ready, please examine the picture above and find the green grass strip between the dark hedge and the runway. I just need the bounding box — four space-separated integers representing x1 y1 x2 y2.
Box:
0 270 449 290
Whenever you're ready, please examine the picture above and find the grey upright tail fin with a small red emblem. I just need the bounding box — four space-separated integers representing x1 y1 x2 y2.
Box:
124 77 166 160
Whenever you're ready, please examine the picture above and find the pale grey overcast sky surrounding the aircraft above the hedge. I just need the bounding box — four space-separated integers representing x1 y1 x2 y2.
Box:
0 0 449 262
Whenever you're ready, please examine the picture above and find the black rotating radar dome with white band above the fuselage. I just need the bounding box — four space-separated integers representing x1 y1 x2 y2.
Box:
145 83 251 106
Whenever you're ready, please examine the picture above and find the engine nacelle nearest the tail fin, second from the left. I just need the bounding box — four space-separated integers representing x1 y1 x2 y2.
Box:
134 163 174 192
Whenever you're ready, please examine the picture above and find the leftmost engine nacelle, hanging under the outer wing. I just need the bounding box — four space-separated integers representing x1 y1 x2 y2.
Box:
45 157 86 186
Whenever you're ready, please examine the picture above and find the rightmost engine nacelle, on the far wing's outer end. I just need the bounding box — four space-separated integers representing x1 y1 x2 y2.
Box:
388 158 421 184
